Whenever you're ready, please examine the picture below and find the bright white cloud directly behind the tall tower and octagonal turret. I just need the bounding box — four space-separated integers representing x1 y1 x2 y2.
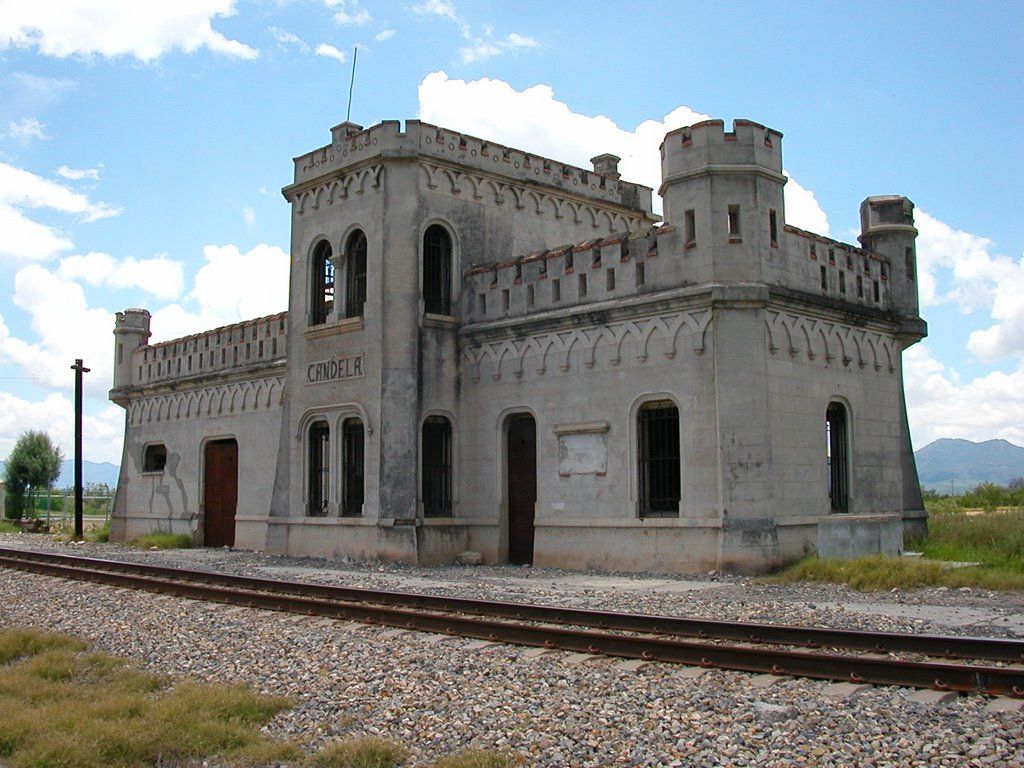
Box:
419 72 828 234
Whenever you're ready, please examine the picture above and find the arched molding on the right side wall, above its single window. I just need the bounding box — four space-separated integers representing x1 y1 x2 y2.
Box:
765 310 900 374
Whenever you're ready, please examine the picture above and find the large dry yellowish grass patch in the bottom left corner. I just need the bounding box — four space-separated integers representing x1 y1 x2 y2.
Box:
0 630 292 768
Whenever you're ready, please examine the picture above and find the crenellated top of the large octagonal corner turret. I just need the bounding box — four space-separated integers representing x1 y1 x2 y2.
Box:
660 120 782 194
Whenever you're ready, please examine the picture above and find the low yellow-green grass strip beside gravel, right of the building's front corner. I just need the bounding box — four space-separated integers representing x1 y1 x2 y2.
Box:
769 555 1024 592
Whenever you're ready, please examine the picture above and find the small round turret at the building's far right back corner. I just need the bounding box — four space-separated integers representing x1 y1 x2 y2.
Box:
857 195 918 317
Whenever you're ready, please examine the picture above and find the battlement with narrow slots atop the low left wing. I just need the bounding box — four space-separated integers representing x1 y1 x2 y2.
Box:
128 312 288 386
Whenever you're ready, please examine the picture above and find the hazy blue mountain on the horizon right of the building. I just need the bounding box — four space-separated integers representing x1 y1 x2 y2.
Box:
913 437 1024 493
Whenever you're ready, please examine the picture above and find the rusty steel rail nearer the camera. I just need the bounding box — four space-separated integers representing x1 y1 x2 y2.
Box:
0 557 1024 698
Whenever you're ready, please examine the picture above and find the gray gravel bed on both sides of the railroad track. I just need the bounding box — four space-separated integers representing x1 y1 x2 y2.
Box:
0 536 1024 768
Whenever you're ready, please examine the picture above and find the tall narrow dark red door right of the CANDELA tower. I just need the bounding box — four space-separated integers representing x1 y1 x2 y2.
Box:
508 415 537 565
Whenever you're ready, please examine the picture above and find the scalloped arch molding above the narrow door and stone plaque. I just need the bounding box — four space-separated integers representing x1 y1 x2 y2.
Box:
462 309 712 382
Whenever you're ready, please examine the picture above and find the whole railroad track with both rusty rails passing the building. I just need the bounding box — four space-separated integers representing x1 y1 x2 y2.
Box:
0 548 1024 698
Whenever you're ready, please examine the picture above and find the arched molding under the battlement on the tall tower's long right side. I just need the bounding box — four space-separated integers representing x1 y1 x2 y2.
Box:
420 163 650 234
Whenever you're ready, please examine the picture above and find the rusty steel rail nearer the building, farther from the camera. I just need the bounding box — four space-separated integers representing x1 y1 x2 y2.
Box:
0 548 1024 663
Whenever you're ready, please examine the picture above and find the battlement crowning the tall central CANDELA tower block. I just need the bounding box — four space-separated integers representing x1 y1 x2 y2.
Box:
283 120 652 215
